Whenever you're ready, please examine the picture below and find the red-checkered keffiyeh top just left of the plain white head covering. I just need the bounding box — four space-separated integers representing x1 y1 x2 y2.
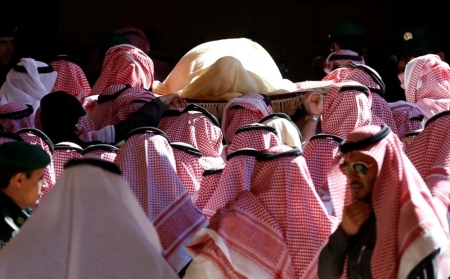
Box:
227 123 281 154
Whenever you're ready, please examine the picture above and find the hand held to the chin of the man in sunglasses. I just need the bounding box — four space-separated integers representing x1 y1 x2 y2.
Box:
341 201 372 236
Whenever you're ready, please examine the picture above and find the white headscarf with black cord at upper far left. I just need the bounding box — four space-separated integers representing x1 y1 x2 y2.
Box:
0 58 58 110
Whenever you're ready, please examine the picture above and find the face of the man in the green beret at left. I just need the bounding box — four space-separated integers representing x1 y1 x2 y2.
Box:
20 168 47 208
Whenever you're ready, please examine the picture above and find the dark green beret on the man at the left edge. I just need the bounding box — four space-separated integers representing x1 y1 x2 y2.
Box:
0 141 50 170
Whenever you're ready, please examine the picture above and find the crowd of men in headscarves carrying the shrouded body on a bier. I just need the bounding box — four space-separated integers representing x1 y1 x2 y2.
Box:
0 22 450 278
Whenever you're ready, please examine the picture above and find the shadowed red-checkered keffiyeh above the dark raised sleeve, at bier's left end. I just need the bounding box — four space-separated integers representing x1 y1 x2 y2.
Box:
110 87 155 125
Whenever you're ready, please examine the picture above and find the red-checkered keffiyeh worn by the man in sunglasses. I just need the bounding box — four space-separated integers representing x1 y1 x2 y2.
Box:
328 125 450 278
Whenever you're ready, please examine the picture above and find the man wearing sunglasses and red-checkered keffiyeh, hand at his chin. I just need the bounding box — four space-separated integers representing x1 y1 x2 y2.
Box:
318 125 450 278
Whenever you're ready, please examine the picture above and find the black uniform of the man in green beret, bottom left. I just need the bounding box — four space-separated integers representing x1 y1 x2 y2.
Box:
0 191 31 250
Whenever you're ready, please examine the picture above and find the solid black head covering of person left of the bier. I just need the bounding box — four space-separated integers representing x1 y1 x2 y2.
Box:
40 91 86 144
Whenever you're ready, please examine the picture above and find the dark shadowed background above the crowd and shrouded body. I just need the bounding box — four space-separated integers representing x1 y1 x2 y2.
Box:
1 0 449 102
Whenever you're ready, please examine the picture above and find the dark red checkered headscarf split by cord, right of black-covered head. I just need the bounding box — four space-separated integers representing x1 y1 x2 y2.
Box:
86 84 126 131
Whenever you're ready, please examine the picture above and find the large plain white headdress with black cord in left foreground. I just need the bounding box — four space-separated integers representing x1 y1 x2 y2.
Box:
0 159 178 279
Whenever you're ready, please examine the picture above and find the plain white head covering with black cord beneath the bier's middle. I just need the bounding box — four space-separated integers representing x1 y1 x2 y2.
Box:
259 112 302 149
